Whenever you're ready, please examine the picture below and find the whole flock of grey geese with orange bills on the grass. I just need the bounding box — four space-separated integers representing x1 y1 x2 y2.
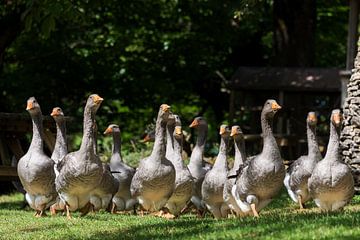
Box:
17 94 354 219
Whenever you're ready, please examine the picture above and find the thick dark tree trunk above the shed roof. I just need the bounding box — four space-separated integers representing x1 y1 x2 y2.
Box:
273 0 316 67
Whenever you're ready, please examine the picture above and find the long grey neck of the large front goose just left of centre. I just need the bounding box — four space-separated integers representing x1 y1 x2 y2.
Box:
150 117 166 161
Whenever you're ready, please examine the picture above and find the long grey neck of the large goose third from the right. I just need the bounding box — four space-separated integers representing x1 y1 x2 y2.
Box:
261 113 280 157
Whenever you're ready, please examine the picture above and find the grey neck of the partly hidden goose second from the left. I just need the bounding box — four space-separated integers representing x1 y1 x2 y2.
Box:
51 120 68 160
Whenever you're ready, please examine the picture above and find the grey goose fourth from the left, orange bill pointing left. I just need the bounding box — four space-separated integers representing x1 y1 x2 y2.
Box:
104 124 137 213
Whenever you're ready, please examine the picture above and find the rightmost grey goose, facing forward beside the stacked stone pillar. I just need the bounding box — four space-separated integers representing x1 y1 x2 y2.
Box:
308 109 354 211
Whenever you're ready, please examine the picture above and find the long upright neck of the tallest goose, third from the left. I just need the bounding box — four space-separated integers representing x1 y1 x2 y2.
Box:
80 106 95 154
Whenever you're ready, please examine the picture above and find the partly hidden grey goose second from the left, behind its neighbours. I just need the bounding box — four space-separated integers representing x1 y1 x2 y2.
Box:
50 107 68 215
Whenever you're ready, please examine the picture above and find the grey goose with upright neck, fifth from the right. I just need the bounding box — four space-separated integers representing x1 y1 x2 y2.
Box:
201 125 230 219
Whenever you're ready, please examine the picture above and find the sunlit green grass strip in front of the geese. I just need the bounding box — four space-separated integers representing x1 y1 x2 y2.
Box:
0 192 360 240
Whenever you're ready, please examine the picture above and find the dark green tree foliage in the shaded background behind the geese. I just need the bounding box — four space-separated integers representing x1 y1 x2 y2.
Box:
0 0 348 154
